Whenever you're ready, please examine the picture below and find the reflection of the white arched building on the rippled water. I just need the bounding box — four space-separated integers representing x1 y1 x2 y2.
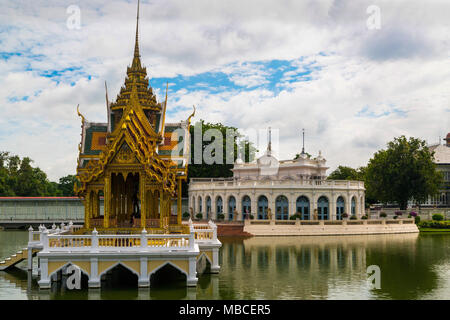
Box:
221 234 418 299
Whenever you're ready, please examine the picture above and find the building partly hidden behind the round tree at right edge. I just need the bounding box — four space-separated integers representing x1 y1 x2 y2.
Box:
422 133 450 207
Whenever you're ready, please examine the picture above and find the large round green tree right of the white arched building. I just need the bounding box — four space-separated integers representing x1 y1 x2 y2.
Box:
365 136 443 210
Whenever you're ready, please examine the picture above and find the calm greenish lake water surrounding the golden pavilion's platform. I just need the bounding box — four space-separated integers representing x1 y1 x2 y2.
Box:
0 231 450 300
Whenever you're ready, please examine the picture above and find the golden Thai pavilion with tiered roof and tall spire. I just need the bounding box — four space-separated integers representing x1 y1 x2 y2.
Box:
75 4 193 233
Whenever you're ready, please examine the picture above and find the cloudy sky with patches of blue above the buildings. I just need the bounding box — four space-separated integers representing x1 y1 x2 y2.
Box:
0 0 450 181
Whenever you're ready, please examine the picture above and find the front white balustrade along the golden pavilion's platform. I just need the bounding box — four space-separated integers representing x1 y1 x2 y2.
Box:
41 229 195 252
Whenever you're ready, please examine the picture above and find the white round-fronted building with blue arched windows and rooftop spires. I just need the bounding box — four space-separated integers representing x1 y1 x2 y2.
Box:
189 134 365 220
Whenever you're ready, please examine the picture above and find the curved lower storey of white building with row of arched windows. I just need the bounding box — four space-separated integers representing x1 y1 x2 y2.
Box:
189 181 365 220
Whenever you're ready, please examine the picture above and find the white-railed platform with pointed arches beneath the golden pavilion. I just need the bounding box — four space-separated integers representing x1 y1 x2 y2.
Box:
7 221 222 289
